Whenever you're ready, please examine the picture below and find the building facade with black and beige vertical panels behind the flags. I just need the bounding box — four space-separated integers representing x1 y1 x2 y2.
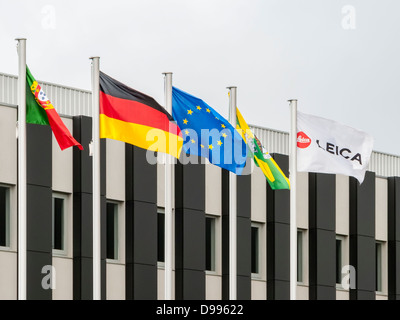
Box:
0 74 400 300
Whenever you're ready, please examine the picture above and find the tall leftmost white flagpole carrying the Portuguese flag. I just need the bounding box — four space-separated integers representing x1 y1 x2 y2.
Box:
15 38 27 300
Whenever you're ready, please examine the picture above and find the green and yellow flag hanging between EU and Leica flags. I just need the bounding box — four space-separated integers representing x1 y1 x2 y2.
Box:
236 108 290 190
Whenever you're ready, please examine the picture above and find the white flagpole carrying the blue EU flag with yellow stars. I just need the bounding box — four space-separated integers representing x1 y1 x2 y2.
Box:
163 72 173 300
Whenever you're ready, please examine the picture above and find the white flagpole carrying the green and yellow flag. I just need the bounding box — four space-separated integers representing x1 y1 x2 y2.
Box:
228 87 237 300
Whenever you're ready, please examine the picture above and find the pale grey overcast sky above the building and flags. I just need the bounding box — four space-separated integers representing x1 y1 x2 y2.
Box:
0 0 400 155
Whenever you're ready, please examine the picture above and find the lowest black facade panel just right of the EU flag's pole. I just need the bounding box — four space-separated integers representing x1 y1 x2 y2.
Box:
175 269 206 300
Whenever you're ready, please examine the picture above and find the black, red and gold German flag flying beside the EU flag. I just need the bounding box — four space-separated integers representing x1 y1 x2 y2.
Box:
100 71 183 158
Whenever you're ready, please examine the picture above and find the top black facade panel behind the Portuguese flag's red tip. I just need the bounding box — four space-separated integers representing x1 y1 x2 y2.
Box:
73 116 92 193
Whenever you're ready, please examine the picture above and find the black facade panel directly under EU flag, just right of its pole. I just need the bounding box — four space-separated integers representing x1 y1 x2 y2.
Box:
175 160 205 211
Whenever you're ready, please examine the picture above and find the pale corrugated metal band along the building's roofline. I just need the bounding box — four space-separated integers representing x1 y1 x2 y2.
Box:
0 73 400 177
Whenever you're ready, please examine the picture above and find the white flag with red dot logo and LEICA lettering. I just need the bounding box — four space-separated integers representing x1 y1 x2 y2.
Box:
297 112 373 184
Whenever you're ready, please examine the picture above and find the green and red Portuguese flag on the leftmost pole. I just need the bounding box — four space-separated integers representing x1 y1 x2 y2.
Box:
26 66 83 150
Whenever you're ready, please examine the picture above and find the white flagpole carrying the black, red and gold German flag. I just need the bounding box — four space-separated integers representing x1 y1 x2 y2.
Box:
90 57 101 300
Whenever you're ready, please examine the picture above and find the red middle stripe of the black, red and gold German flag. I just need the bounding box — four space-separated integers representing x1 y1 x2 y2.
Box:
100 91 181 135
